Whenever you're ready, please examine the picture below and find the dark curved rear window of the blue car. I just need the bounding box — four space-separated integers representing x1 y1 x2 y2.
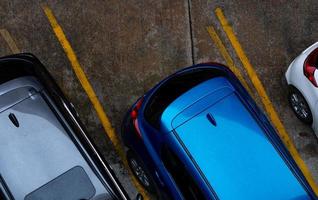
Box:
144 69 225 129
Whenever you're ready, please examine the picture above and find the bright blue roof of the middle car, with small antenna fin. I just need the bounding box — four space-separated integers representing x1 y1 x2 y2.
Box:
161 77 310 200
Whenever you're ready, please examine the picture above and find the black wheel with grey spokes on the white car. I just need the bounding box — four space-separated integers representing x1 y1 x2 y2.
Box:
288 87 312 124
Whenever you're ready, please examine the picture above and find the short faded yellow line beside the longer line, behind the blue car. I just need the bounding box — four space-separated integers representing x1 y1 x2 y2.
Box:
207 26 254 96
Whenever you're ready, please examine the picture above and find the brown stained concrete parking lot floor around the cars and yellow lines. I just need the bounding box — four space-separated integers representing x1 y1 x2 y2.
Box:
0 0 318 199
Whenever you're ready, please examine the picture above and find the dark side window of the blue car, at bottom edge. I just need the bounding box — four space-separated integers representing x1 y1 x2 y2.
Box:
161 146 205 200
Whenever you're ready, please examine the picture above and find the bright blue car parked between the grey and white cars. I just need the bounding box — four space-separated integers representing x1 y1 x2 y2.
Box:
121 63 317 200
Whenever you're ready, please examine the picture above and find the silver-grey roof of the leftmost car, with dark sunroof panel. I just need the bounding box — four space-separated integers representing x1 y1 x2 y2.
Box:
0 77 109 199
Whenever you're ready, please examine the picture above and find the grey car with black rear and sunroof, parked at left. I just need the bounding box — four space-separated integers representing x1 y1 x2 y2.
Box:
0 54 140 200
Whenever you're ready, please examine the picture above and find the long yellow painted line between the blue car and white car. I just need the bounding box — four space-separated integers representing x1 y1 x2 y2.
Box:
215 8 318 195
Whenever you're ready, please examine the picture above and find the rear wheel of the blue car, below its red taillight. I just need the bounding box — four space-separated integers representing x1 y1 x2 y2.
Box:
127 150 155 193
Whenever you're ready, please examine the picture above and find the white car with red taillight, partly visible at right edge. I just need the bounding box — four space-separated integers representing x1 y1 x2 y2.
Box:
285 42 318 136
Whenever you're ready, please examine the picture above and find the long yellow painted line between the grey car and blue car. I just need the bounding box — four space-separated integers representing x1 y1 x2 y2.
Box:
43 6 149 199
